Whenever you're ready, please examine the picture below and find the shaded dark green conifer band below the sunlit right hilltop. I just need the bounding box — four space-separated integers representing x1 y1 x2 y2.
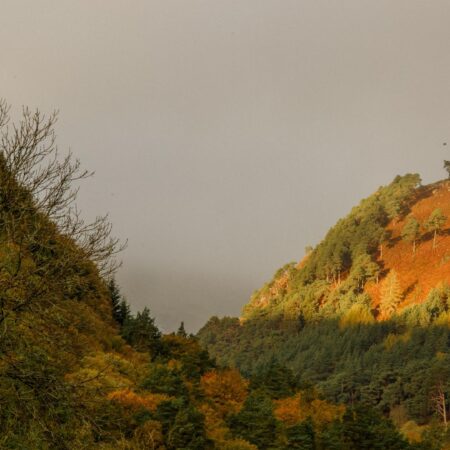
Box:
199 285 450 424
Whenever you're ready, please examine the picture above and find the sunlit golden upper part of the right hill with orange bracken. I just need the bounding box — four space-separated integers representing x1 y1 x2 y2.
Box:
242 174 450 321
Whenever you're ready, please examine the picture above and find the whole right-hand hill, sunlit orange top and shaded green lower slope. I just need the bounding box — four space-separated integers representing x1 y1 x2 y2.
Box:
198 174 450 446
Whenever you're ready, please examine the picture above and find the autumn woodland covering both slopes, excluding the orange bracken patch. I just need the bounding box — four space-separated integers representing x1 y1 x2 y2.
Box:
0 102 450 450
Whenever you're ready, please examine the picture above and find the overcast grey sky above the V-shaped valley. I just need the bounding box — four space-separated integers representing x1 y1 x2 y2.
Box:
0 0 450 330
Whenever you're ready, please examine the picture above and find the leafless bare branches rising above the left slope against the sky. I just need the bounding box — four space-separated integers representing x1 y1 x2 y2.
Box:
0 100 124 275
